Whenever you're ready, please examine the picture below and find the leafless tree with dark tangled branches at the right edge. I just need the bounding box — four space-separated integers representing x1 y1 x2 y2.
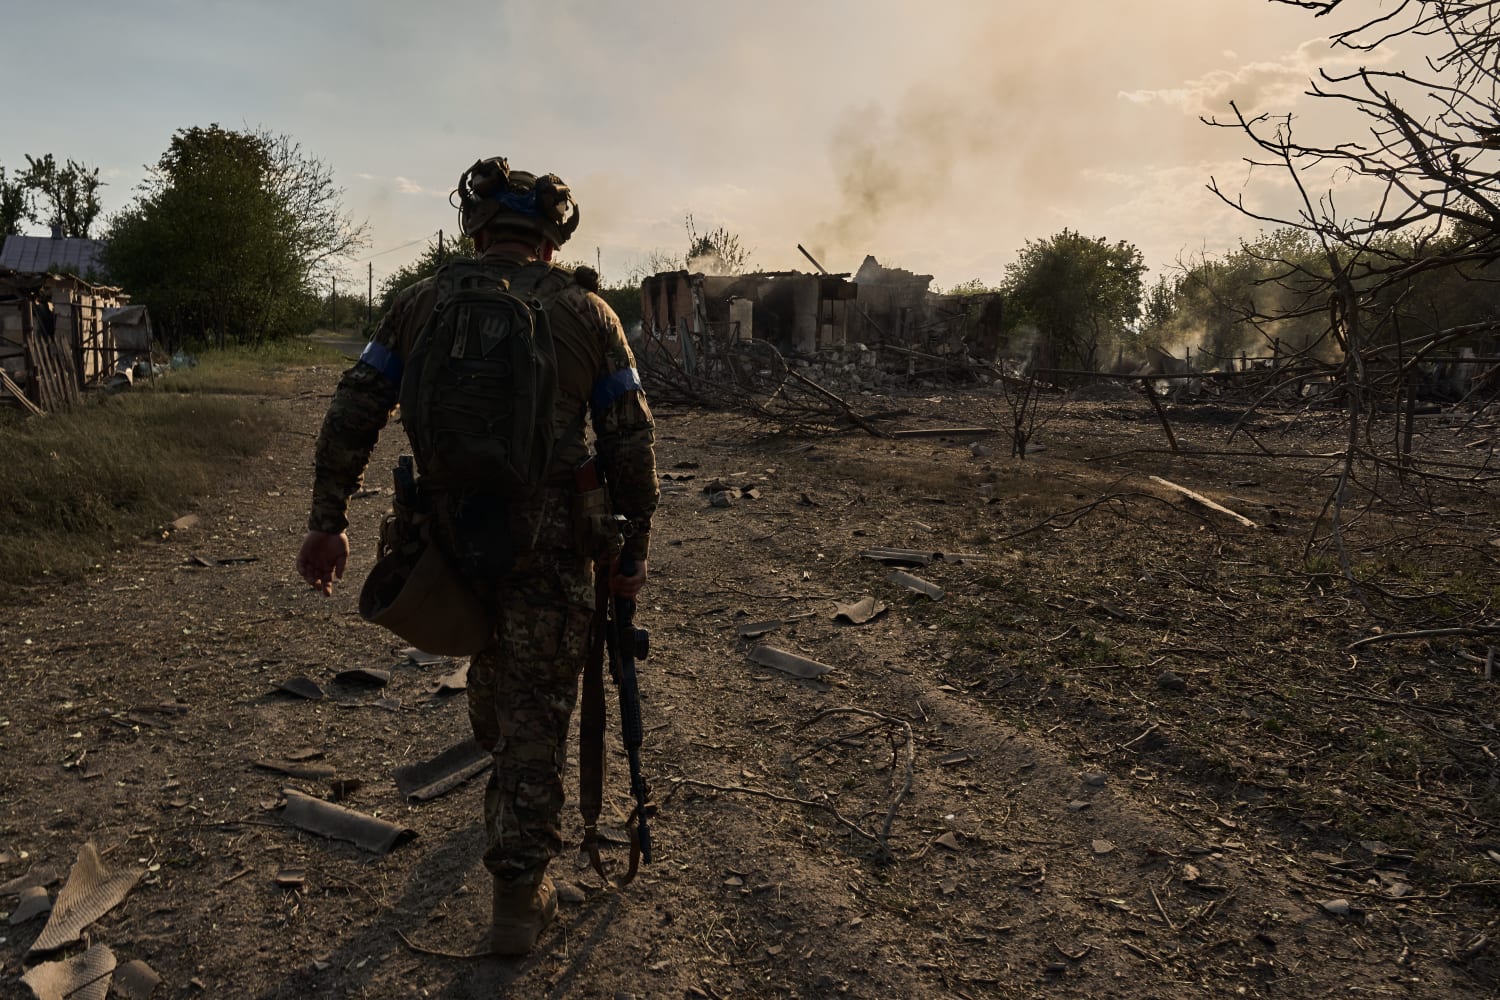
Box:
1206 0 1500 614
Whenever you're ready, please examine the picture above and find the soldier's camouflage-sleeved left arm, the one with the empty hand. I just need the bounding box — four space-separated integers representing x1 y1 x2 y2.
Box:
308 284 413 534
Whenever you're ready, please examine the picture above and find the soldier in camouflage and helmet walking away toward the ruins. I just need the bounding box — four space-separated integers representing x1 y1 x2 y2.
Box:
297 157 659 955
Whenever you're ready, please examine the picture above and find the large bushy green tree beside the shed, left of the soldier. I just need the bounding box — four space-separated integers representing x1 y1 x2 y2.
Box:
104 124 365 346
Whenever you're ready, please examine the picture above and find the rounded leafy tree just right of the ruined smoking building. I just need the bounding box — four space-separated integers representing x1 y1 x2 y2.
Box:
1002 229 1146 370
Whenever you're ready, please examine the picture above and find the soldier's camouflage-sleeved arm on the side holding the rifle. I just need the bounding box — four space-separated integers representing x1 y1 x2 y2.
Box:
588 295 660 561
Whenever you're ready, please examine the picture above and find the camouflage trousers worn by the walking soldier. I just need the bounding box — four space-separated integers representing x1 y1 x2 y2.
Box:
455 488 594 885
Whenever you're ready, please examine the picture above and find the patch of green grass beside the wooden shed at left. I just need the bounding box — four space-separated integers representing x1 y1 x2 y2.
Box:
0 342 325 600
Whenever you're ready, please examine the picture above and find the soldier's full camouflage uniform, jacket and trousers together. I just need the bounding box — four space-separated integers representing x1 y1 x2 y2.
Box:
308 255 659 885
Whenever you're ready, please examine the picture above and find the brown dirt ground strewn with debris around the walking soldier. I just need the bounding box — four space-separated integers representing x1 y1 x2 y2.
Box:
0 370 1500 999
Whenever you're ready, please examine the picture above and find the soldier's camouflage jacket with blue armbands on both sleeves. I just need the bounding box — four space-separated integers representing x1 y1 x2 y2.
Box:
308 256 659 559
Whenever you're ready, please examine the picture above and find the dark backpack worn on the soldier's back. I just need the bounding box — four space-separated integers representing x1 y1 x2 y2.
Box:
401 261 567 498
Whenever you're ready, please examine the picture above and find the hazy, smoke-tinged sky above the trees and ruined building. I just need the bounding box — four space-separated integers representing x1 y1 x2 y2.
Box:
0 0 1380 288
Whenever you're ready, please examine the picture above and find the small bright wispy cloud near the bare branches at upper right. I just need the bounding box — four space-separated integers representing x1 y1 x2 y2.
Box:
1118 39 1395 117
